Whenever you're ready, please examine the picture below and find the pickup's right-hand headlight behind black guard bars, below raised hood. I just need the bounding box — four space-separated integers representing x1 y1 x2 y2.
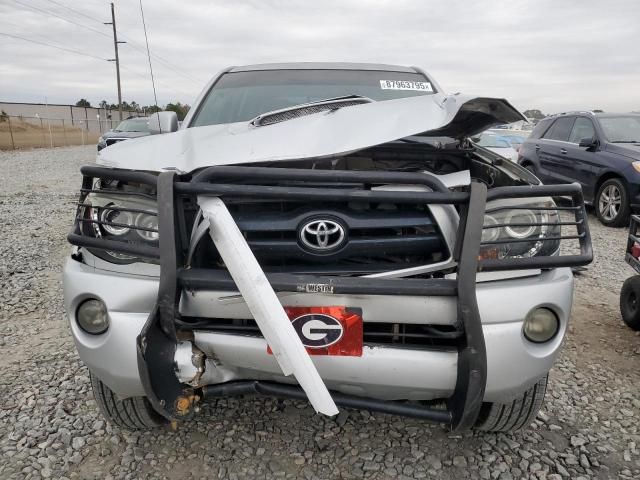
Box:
480 198 560 259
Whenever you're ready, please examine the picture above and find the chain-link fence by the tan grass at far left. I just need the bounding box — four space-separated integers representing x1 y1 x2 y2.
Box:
0 115 120 150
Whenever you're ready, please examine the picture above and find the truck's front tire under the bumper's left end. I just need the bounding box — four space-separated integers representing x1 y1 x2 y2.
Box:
90 373 167 430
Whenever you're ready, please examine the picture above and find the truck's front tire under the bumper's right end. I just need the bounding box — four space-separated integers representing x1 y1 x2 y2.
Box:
473 375 549 432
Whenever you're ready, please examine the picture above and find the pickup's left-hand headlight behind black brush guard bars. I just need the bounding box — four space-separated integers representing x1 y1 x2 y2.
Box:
79 189 159 263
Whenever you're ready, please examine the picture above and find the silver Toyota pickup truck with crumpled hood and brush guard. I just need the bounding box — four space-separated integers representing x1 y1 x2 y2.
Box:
64 63 592 431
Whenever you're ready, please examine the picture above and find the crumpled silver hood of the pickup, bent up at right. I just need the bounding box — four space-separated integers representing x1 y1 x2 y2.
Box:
97 94 526 172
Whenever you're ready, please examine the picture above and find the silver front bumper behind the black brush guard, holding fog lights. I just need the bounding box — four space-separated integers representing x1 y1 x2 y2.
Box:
64 259 573 402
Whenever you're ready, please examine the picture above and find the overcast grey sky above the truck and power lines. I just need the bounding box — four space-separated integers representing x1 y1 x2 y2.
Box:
0 0 640 113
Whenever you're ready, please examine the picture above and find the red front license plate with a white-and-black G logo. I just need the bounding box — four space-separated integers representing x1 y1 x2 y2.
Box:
267 307 363 357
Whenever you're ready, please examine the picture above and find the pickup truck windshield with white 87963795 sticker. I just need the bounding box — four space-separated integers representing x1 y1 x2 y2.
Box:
191 70 434 127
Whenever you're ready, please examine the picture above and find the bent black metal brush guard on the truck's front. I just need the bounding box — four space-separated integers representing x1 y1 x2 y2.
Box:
68 166 593 430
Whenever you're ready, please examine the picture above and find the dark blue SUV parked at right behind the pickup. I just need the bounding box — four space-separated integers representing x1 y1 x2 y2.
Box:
518 112 640 227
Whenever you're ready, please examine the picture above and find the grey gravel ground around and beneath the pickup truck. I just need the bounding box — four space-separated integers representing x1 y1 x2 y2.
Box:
0 147 640 480
